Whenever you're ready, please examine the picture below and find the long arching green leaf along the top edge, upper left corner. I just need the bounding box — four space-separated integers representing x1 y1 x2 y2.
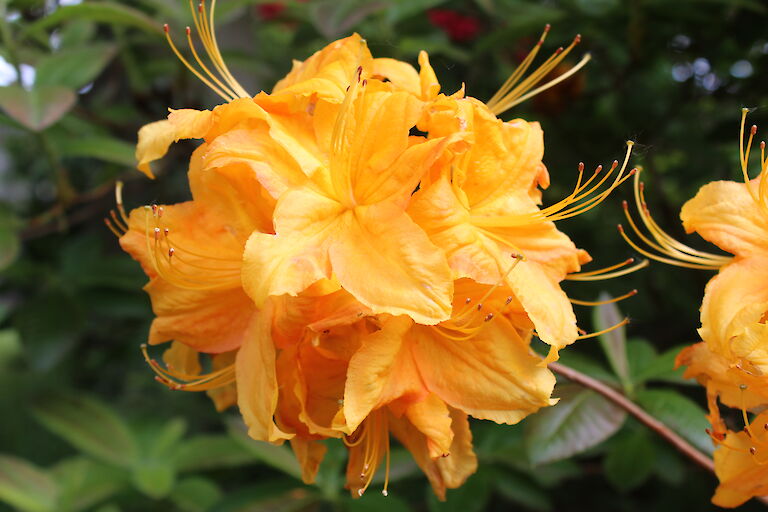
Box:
21 2 163 38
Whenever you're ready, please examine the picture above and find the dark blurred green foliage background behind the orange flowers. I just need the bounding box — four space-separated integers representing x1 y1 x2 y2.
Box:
0 0 768 512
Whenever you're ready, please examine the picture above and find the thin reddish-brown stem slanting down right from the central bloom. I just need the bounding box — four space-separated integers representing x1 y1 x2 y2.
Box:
548 363 768 505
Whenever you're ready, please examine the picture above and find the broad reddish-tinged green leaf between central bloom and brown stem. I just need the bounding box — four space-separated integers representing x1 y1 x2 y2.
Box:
524 386 627 465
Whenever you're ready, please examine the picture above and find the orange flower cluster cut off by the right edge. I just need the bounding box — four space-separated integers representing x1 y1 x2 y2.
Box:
619 109 768 507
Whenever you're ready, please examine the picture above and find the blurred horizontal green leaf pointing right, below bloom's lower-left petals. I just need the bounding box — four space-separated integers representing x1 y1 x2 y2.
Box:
173 435 258 471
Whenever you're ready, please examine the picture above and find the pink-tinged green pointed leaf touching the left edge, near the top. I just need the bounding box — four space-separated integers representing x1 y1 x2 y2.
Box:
0 85 77 132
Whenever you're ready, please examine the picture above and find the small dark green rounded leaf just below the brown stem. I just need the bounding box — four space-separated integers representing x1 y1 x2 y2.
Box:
603 427 656 491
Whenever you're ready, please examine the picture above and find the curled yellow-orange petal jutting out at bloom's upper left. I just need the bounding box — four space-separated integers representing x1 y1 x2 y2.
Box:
136 109 213 178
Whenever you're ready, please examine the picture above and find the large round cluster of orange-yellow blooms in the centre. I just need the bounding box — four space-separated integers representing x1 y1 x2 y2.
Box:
108 0 631 497
